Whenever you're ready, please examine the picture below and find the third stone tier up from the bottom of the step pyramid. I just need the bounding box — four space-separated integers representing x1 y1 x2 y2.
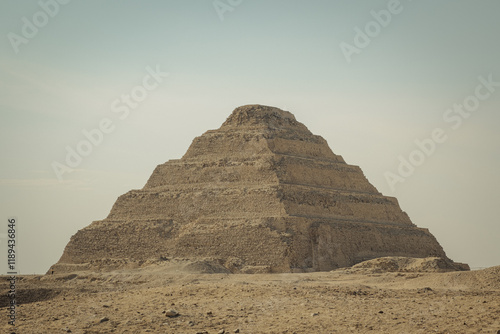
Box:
143 154 379 194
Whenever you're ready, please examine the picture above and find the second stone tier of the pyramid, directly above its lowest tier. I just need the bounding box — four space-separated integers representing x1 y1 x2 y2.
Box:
108 183 412 225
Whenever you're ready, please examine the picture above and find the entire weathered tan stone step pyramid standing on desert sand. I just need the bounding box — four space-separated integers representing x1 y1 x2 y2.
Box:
51 105 458 272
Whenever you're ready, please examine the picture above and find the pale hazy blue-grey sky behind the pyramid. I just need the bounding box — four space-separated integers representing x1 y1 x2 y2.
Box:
0 0 500 273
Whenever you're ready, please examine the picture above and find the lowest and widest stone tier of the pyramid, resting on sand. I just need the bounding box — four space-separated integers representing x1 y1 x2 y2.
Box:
49 217 458 273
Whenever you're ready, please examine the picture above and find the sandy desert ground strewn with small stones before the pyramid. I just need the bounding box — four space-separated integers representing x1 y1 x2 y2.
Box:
0 263 500 334
